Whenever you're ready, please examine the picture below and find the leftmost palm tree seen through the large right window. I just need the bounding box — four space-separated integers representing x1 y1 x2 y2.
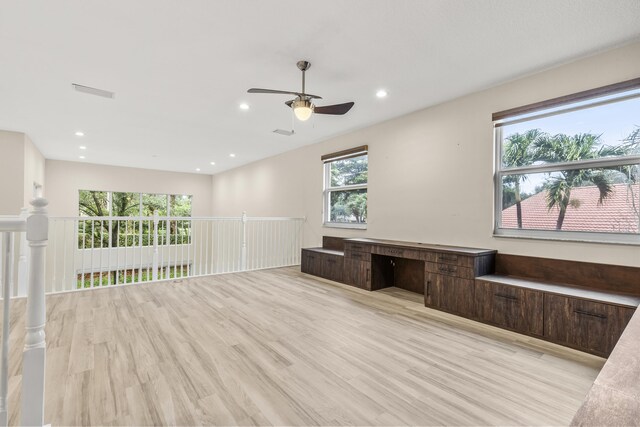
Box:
502 129 546 228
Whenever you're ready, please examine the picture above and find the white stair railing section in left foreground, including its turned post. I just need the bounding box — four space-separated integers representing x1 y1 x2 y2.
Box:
0 196 49 426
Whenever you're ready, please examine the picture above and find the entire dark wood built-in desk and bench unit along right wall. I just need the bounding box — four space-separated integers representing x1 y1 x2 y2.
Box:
302 237 640 357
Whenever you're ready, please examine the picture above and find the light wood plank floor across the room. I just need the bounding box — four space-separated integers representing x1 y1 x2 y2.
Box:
2 268 604 425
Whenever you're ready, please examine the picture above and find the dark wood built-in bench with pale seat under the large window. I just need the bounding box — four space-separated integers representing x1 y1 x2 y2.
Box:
475 254 640 357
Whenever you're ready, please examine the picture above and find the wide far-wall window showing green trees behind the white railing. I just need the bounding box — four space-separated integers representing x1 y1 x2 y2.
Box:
78 190 192 249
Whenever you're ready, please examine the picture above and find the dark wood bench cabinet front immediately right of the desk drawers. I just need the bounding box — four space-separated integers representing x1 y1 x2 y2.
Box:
475 280 544 336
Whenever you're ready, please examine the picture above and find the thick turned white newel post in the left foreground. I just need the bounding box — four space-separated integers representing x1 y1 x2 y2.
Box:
21 197 49 426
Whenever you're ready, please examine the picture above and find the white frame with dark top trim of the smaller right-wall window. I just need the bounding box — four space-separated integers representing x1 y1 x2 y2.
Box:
321 145 369 230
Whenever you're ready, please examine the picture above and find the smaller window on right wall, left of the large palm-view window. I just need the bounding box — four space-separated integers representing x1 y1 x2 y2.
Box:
322 145 369 228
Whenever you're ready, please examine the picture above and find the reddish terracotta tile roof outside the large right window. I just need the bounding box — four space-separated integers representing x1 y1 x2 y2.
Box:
502 184 640 233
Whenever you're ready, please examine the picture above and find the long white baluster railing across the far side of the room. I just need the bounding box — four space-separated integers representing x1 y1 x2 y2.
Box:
46 212 304 293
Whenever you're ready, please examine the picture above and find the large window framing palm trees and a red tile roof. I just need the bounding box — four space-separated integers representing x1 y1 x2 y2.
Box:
493 79 640 244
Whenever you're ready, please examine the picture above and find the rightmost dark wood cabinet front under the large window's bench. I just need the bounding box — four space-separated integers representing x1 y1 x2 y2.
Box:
544 294 635 357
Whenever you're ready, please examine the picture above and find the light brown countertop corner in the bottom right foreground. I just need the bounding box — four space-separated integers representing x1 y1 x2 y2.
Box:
571 310 640 426
